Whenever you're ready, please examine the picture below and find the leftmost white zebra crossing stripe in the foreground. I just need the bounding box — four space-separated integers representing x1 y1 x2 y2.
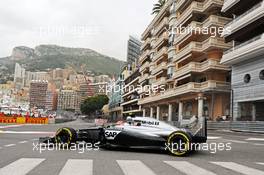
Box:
0 158 45 175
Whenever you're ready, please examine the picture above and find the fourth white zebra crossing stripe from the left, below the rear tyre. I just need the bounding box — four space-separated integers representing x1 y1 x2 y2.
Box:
164 161 216 175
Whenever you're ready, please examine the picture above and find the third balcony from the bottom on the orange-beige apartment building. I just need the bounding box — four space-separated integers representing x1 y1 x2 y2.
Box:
173 37 232 62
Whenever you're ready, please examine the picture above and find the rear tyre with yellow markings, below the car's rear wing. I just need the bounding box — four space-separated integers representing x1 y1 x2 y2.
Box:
167 131 192 156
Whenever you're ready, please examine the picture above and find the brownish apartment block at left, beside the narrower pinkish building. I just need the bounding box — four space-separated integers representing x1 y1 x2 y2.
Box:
29 80 48 109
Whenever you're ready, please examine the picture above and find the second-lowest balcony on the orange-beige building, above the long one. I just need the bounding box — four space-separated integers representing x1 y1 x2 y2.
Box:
173 60 230 79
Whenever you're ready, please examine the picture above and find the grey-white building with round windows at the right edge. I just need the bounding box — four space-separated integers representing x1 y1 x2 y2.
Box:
221 0 264 121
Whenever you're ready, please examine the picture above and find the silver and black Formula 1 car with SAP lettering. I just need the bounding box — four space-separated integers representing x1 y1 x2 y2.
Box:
39 117 207 156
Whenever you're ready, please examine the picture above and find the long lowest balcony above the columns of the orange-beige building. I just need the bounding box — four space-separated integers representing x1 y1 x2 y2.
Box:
138 80 230 105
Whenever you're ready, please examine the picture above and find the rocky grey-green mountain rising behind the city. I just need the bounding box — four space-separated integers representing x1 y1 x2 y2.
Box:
0 45 124 75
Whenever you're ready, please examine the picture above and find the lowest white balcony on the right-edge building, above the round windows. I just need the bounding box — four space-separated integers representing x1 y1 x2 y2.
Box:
221 34 264 65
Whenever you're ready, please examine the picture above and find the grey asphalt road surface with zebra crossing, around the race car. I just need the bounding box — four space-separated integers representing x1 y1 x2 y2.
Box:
0 120 264 175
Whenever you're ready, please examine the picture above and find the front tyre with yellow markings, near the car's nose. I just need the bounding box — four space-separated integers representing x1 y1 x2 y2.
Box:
55 127 77 146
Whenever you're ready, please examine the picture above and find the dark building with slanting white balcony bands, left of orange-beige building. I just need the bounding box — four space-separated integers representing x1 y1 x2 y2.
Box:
121 63 142 117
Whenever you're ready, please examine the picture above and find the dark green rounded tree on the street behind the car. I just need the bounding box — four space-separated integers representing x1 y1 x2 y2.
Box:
81 95 109 117
